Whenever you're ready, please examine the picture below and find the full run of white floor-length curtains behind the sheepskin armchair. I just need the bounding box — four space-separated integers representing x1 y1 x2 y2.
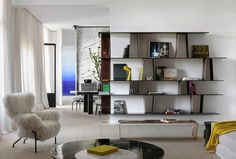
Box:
0 5 48 134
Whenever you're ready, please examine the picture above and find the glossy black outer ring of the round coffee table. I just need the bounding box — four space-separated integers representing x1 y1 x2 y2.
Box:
50 139 164 159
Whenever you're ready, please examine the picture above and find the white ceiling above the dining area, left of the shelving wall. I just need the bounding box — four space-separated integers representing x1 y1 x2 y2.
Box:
12 0 110 30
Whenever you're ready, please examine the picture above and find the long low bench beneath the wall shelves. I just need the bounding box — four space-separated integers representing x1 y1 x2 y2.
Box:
118 120 198 139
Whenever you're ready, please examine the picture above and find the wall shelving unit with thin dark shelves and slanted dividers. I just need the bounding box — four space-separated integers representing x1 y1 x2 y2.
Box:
101 32 225 115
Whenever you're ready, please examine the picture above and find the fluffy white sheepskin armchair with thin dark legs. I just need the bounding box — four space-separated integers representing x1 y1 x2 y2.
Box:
3 93 60 152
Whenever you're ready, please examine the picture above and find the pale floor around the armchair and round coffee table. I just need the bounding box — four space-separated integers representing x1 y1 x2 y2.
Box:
0 108 219 159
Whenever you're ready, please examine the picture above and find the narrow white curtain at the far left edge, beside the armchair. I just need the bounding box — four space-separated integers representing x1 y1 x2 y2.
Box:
0 0 12 136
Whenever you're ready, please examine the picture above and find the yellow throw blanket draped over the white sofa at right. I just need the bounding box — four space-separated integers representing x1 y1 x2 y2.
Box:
206 121 236 153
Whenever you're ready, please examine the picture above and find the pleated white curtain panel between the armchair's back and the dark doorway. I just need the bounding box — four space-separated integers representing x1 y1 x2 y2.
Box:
15 8 48 108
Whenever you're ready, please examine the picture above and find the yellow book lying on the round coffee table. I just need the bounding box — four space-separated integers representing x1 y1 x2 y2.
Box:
87 145 118 156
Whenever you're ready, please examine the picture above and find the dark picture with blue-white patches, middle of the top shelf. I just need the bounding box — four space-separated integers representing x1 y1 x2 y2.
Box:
149 41 170 58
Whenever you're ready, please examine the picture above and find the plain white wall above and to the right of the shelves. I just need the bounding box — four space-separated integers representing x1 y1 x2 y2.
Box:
110 0 236 121
